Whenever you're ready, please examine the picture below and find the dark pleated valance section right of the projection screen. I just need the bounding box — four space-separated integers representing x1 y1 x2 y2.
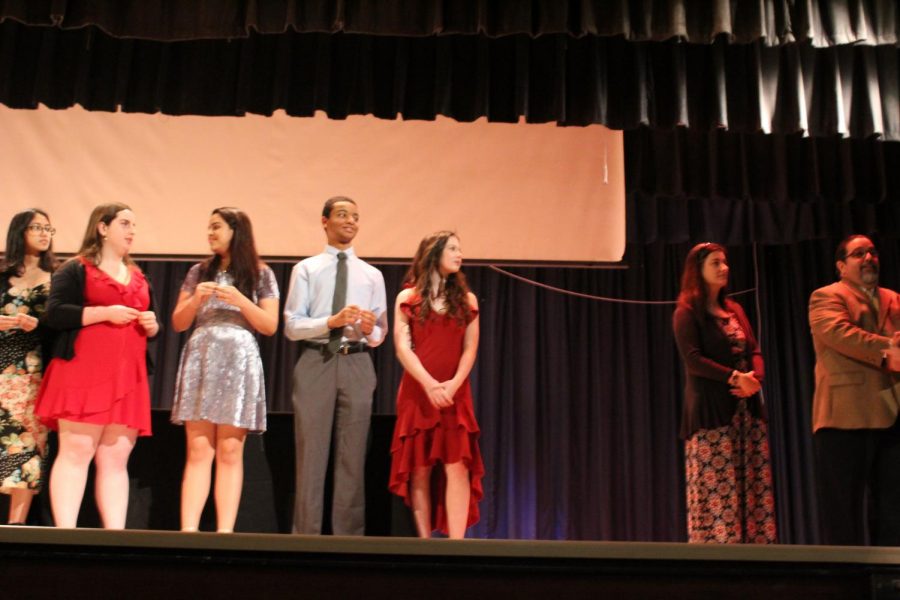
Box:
625 129 900 245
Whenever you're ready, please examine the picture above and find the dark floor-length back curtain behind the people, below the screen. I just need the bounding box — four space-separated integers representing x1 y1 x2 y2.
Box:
135 236 900 543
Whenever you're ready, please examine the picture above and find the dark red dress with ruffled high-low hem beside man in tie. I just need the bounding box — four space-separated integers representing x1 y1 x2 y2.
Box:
388 295 484 533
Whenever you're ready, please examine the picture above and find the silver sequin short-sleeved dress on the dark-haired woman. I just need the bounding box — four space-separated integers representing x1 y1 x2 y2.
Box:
172 264 278 433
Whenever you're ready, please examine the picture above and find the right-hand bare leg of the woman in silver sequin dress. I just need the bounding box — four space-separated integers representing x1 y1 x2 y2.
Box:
215 425 247 533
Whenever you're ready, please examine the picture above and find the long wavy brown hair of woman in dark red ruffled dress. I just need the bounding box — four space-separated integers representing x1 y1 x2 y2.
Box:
403 231 469 323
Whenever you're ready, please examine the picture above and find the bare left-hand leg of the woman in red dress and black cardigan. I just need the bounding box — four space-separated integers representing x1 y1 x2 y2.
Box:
50 420 103 528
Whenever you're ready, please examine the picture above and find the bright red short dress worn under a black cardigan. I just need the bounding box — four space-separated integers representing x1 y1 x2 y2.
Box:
35 260 151 435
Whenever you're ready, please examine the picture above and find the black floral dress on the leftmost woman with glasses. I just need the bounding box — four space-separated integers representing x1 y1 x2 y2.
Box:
0 282 50 494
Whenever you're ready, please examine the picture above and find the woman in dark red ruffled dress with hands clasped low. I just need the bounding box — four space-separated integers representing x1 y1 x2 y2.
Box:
389 231 484 539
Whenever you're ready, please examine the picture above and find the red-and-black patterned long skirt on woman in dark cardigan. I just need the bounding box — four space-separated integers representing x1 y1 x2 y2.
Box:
685 400 777 544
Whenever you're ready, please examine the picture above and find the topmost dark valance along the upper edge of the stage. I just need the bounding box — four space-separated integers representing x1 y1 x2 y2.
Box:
0 0 900 47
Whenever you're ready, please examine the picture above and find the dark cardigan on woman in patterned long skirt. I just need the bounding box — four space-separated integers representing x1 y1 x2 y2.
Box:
672 300 766 439
